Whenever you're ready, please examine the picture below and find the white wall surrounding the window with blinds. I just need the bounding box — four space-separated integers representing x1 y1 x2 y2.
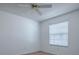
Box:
41 11 79 54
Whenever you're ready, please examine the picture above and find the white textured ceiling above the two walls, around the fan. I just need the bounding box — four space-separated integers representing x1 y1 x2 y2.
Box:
0 3 79 21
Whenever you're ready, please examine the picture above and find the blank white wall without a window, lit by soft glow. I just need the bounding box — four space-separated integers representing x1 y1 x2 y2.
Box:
0 11 40 54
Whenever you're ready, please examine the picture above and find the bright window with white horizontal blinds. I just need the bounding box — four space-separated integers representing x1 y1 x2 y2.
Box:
49 21 68 46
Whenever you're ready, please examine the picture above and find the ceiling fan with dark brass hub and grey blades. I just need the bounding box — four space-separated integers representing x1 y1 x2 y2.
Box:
19 3 52 15
